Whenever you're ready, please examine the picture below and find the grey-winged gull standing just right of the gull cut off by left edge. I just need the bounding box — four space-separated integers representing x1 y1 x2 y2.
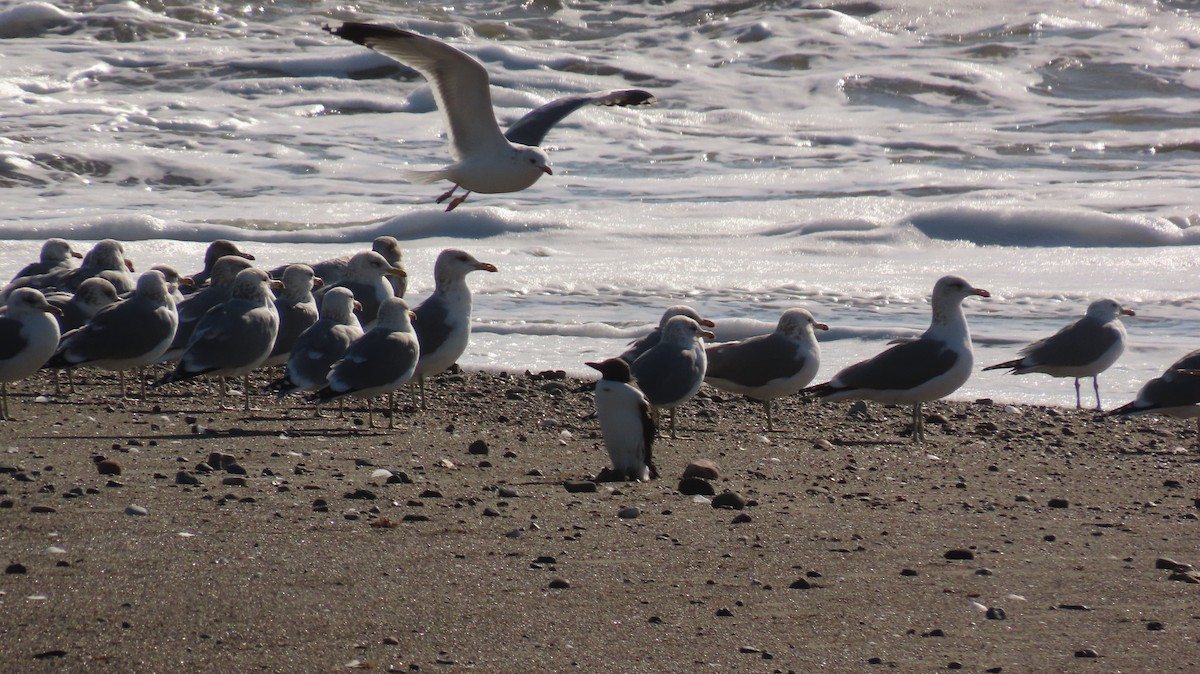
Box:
46 270 179 399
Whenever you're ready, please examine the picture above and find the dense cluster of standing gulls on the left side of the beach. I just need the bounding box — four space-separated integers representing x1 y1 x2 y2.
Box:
0 236 497 427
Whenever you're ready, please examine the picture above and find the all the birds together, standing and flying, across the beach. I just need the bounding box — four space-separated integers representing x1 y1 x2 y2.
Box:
0 18 1200 480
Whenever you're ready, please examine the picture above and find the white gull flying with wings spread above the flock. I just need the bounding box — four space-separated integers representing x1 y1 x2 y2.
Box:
325 23 654 211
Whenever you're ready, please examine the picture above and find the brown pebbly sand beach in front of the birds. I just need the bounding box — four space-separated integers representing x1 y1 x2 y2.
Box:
0 373 1200 673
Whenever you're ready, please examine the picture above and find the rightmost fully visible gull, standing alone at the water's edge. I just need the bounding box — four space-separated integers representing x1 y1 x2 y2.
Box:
984 300 1135 411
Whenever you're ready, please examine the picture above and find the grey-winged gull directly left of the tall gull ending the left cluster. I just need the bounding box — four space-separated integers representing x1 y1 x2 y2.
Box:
308 297 420 428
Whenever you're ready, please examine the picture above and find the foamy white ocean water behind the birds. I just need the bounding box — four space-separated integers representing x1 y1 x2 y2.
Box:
0 0 1200 405
